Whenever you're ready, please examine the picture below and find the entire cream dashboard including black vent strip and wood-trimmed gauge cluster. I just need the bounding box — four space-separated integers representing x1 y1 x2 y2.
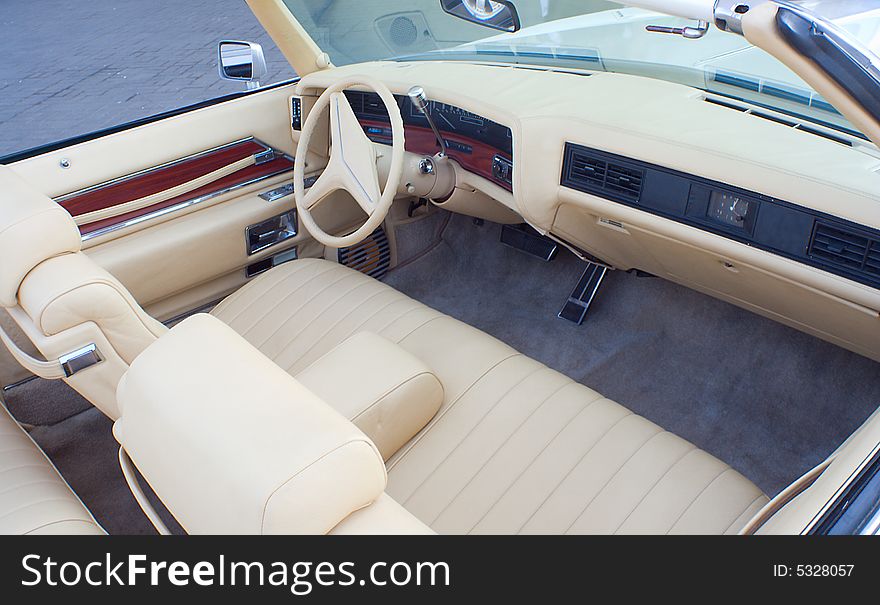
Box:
298 61 880 361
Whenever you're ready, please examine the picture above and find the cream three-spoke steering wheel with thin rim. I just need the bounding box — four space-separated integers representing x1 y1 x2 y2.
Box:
293 76 404 248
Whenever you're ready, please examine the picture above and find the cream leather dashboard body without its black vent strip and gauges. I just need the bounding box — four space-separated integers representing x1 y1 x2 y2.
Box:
297 62 880 360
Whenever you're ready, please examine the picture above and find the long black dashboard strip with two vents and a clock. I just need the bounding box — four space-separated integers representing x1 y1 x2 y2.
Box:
560 142 880 288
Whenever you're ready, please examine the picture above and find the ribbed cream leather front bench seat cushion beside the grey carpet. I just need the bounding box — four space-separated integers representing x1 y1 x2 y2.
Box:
214 259 767 534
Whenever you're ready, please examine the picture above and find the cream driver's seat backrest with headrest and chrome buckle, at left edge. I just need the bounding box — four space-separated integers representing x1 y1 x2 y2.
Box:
0 166 166 418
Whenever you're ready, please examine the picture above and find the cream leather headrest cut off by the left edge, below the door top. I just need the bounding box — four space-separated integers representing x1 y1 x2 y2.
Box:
0 166 82 307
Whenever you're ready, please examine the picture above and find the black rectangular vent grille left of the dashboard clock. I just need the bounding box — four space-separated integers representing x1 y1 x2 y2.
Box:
562 143 645 202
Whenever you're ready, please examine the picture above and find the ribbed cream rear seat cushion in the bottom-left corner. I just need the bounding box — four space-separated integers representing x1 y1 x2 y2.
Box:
0 405 104 535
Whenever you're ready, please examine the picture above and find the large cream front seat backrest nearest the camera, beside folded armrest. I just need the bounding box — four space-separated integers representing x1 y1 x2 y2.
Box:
114 314 387 534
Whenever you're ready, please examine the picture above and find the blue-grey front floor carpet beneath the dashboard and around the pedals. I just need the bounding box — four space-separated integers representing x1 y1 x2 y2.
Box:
385 216 880 495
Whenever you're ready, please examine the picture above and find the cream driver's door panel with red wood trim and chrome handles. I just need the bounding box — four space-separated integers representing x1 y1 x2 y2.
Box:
1 84 359 320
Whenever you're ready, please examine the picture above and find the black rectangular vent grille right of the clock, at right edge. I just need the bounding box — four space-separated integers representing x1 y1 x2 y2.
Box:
810 222 880 279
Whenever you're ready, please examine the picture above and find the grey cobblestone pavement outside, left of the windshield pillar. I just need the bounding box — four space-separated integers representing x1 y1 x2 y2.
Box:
0 0 294 156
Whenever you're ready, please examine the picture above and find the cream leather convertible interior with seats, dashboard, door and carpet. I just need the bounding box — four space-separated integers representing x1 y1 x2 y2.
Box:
0 1 880 534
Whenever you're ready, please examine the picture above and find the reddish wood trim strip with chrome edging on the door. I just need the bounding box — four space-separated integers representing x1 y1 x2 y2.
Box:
55 138 293 239
